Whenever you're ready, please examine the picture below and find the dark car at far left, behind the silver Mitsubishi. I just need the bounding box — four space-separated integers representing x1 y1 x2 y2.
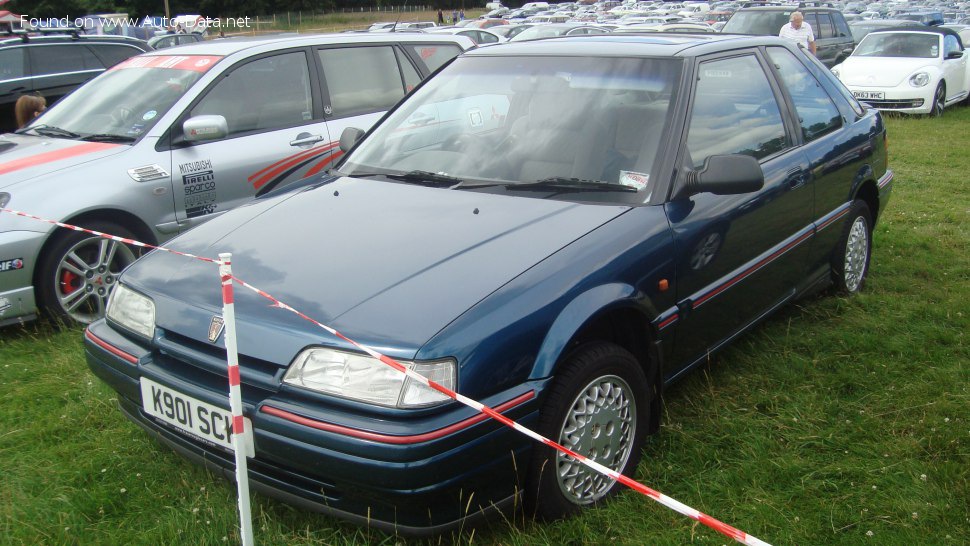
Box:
0 31 152 133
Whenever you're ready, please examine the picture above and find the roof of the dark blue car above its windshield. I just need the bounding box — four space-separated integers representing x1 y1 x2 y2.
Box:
464 32 792 57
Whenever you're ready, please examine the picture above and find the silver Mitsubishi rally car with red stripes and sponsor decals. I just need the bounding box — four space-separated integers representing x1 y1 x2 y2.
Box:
0 34 474 326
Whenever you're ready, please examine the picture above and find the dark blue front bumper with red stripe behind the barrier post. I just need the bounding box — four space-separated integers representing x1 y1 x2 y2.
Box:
85 320 545 536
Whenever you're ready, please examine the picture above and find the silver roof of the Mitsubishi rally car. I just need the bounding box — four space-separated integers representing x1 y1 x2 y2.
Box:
142 32 474 56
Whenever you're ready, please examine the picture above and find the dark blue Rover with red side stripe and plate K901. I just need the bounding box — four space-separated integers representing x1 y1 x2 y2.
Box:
85 34 892 534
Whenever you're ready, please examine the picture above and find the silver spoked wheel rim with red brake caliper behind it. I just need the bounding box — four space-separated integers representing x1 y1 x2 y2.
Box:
53 237 135 324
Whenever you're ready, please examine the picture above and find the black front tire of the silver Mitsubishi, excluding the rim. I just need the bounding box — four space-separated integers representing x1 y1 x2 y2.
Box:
34 222 138 325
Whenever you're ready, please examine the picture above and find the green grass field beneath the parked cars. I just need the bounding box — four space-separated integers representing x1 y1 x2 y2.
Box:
0 108 970 545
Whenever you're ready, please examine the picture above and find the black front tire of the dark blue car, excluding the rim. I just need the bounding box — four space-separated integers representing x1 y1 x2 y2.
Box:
525 342 653 520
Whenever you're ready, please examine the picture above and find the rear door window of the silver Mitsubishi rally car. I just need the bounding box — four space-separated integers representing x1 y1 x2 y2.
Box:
317 46 404 117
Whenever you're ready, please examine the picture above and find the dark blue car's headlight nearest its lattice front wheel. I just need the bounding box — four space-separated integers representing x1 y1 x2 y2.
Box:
283 347 456 408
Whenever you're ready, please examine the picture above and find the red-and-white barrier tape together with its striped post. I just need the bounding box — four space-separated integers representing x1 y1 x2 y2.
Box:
0 209 770 546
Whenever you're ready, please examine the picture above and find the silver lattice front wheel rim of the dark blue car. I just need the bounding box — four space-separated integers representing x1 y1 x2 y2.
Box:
556 375 637 505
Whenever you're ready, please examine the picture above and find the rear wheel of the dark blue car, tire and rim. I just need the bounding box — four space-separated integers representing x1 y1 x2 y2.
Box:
832 199 872 294
